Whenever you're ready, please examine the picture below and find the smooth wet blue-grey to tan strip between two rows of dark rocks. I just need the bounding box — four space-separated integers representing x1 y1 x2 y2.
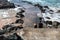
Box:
20 3 40 27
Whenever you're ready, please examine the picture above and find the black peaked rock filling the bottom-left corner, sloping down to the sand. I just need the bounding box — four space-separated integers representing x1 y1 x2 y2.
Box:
0 33 23 40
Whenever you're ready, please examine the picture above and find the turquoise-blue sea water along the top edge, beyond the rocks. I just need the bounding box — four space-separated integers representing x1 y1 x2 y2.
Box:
8 0 60 8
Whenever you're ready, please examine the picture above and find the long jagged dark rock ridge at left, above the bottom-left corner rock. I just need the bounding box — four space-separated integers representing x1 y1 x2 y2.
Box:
1 25 23 33
